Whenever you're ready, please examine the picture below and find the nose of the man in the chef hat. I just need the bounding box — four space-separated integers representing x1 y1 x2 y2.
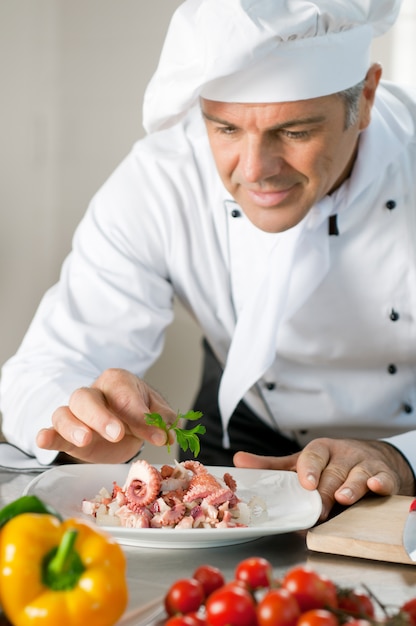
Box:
239 136 283 183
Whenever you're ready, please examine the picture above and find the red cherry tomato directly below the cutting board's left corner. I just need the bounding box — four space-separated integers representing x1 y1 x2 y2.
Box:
282 566 338 612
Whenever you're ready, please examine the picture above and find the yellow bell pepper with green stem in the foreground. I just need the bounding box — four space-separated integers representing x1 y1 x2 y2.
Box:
0 513 128 626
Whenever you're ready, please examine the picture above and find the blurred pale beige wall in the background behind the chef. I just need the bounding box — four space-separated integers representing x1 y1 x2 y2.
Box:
0 0 416 462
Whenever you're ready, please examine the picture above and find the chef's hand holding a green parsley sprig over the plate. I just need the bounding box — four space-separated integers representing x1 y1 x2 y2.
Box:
36 369 176 463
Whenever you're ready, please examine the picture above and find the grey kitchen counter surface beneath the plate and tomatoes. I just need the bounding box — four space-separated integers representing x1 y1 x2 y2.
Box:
0 472 416 626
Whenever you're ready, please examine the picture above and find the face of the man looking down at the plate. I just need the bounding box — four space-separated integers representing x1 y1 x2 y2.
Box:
201 84 369 232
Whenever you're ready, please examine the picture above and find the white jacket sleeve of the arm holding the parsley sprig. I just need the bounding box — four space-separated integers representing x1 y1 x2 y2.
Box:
0 145 173 463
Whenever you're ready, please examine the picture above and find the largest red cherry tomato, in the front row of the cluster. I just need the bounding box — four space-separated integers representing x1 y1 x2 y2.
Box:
205 585 257 626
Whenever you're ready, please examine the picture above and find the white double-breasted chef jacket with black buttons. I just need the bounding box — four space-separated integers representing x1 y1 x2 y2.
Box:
0 83 416 470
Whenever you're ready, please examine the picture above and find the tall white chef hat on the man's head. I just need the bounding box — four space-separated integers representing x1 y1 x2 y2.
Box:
143 0 402 132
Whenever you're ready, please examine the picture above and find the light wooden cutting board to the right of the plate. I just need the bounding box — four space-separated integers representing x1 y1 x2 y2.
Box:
306 496 416 565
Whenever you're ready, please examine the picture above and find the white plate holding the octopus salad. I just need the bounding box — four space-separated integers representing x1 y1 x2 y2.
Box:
25 465 322 548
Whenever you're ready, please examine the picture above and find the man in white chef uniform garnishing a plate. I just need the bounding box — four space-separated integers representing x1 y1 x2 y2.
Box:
1 0 416 517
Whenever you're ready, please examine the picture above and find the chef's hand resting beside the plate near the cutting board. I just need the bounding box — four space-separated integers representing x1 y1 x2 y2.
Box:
234 438 415 521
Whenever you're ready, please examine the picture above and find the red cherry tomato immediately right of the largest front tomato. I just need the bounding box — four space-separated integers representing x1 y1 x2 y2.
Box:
257 589 301 626
